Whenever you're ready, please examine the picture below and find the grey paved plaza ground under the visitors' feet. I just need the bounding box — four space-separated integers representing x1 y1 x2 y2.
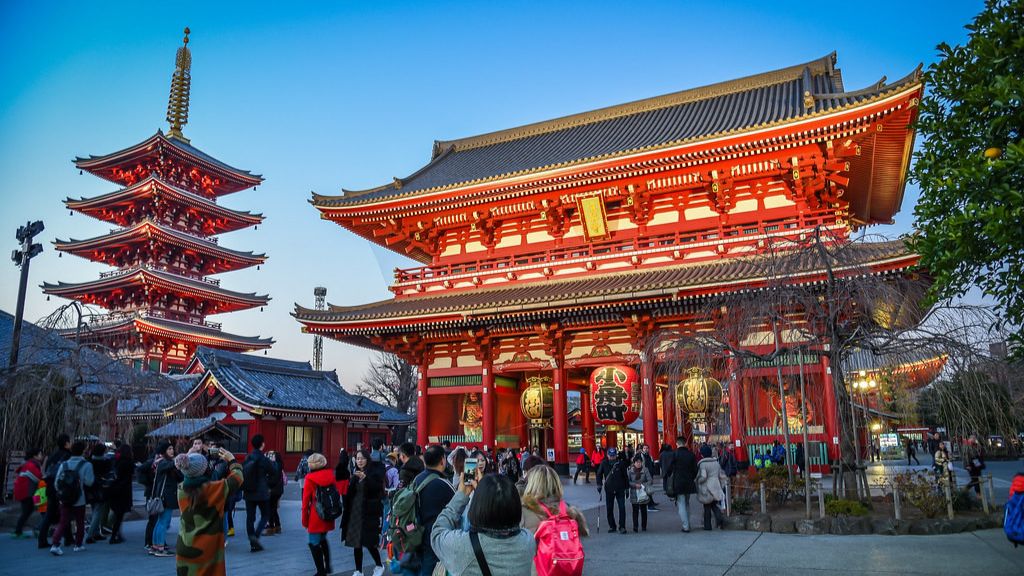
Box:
0 471 1024 576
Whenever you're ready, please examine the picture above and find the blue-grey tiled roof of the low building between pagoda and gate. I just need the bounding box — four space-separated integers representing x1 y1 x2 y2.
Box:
196 346 412 423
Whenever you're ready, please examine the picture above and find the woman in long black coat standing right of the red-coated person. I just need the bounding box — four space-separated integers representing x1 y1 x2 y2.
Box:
345 450 384 576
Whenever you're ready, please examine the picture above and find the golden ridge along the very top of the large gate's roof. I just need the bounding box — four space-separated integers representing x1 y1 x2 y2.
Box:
433 50 838 153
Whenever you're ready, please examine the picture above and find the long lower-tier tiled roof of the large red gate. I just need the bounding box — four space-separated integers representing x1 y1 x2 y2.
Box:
293 240 918 335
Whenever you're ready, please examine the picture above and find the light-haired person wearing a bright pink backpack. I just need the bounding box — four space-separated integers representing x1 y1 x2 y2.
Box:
521 465 590 576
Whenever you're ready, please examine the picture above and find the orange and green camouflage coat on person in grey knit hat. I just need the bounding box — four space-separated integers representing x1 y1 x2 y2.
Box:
174 462 243 576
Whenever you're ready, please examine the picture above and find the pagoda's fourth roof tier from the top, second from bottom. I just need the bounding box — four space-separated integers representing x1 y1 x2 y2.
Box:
42 264 270 314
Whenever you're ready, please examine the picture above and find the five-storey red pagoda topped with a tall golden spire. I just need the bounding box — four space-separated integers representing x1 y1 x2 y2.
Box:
43 29 273 372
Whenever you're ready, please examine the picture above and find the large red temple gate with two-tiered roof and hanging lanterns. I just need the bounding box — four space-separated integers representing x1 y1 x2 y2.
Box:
294 53 923 470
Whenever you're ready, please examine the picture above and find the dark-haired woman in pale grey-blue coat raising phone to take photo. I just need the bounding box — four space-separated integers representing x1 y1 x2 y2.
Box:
430 466 540 576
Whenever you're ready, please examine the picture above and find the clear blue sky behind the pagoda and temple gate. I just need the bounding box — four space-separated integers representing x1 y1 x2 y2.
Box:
0 0 982 385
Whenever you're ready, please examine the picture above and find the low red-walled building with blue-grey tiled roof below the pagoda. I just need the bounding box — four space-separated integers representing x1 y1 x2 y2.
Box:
118 346 413 470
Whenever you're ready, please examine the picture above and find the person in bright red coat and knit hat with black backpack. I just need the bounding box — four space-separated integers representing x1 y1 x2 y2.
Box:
302 452 343 576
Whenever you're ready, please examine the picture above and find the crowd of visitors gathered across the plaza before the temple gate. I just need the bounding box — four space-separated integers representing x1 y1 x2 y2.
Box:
13 428 999 576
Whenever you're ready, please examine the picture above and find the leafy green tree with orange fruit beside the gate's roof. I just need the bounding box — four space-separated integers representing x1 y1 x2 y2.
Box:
910 0 1024 351
